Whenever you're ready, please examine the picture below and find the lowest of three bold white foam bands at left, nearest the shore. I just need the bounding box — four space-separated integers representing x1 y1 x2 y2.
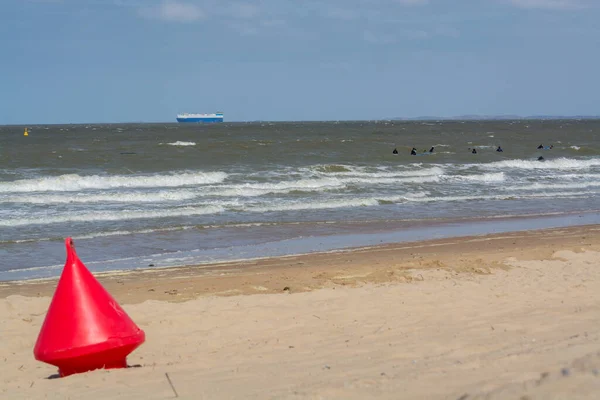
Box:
0 205 224 227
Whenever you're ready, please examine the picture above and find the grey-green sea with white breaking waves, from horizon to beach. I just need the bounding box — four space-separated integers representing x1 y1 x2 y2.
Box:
0 119 600 281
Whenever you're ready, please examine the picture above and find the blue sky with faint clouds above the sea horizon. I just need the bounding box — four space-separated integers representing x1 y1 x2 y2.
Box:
0 0 600 124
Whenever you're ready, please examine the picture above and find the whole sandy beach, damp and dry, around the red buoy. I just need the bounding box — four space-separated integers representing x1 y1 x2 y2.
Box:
0 225 600 400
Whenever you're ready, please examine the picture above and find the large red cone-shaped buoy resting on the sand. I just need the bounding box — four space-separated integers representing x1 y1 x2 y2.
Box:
33 238 145 376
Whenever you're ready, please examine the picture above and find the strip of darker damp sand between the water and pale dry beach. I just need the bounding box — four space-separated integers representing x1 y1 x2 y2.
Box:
0 224 600 303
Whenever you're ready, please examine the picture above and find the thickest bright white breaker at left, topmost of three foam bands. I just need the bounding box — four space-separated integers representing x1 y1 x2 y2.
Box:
0 172 227 193
